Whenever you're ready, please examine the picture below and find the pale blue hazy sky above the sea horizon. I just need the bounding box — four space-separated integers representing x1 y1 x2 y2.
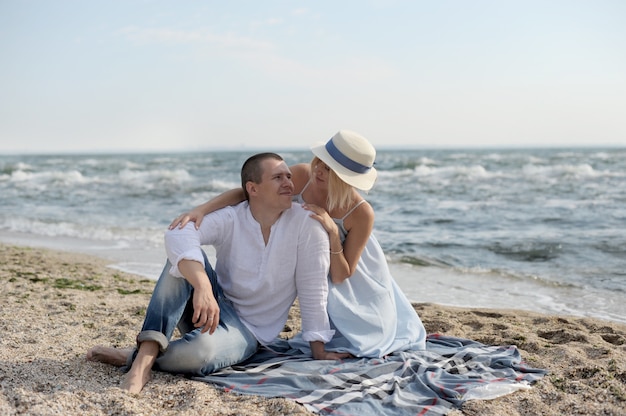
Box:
0 0 626 154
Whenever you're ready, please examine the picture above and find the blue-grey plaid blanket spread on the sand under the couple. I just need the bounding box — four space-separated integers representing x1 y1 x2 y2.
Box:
194 334 547 416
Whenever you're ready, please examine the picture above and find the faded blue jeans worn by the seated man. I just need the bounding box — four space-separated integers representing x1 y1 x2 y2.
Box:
129 253 258 376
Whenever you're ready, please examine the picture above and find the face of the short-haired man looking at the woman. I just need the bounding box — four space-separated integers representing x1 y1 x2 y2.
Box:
257 159 293 210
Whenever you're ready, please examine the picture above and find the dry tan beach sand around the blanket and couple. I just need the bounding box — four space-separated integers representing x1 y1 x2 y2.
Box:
0 245 626 416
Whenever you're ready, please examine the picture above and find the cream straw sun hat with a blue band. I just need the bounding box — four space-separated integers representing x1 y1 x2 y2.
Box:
311 130 377 191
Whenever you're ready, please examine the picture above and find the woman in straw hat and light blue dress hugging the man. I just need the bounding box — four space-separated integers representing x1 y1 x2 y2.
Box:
170 130 426 357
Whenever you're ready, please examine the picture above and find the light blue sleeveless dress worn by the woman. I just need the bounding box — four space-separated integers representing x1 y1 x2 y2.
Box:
289 188 426 357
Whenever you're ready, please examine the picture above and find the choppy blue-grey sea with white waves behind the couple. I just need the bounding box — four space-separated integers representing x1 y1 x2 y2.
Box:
0 148 626 323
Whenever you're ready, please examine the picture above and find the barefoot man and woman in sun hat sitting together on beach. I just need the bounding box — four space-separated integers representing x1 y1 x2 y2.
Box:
87 130 426 393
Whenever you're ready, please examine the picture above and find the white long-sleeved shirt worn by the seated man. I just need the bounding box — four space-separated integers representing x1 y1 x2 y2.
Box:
165 201 335 345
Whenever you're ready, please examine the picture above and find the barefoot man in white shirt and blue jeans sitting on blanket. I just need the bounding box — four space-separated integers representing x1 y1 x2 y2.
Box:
87 153 349 393
